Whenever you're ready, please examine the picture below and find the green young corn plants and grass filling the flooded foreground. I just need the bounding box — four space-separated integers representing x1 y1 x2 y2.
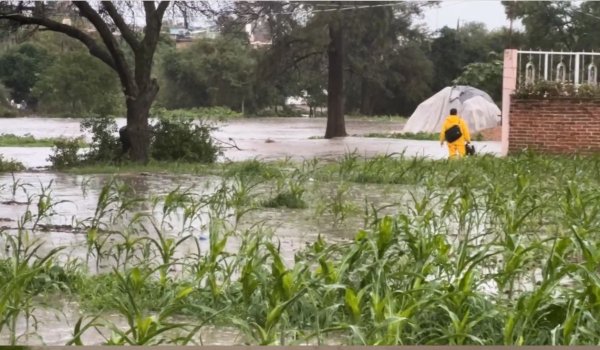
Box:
0 153 600 345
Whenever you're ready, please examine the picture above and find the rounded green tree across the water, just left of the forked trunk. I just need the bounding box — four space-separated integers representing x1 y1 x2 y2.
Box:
32 51 123 117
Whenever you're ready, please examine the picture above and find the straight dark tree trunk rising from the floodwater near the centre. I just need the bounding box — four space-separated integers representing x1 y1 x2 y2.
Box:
325 15 348 139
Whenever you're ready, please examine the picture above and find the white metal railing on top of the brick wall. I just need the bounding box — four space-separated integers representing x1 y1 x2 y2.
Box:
517 51 600 86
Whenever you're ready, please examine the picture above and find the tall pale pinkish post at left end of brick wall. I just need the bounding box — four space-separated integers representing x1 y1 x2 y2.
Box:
501 50 518 156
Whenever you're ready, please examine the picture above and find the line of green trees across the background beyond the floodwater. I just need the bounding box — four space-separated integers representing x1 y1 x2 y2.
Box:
0 1 600 116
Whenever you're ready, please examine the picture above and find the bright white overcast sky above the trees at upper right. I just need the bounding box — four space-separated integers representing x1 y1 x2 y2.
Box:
423 0 509 31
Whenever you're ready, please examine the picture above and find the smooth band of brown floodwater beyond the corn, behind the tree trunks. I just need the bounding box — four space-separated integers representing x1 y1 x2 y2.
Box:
0 118 500 168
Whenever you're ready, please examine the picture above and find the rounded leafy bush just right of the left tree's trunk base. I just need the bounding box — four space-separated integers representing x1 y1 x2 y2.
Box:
151 115 220 163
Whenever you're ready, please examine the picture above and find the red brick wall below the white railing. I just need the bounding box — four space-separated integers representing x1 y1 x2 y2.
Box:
508 98 600 153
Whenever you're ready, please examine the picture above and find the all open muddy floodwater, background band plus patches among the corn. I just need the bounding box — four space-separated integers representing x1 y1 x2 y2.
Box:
0 118 500 345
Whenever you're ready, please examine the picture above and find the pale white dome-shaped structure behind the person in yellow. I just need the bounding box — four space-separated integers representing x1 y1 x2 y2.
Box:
402 85 502 133
